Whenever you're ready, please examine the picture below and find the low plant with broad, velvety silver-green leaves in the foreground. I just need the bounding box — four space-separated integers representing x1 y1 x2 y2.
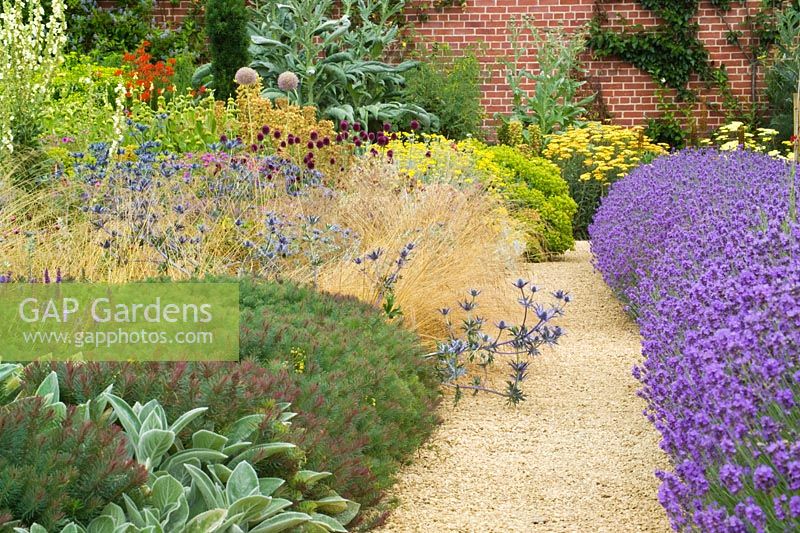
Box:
10 390 359 533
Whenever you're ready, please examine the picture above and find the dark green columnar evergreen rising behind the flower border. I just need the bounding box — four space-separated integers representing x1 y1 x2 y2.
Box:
206 0 250 100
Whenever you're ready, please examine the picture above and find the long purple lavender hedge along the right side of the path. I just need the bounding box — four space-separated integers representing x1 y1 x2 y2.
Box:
590 150 800 532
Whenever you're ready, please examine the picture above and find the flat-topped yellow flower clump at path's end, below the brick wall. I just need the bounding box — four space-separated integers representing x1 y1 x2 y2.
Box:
542 122 669 182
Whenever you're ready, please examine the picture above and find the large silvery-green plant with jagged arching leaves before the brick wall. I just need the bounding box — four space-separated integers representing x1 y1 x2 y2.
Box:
242 0 437 127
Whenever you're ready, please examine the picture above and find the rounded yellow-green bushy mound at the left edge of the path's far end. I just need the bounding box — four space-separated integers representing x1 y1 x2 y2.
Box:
491 146 577 261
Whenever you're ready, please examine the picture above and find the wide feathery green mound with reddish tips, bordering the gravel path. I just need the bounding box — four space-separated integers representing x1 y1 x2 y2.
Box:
22 280 439 504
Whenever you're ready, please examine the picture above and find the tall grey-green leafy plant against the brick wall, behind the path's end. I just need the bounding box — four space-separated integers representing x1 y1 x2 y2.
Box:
500 18 594 135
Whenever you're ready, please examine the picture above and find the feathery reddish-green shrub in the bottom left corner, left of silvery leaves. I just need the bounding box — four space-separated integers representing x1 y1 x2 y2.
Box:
0 396 147 531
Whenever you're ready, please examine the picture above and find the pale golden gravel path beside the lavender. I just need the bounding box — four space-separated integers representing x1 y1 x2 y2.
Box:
379 242 669 533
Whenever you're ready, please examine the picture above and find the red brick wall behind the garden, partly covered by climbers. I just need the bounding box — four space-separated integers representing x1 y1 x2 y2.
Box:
120 0 762 129
